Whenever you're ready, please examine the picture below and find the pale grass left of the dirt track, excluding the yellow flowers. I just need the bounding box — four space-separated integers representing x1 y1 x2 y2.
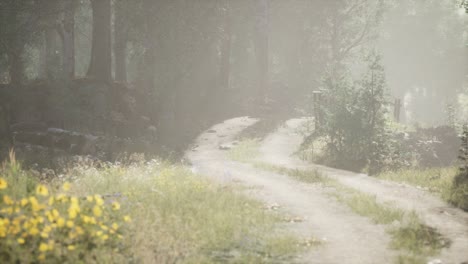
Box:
0 155 301 263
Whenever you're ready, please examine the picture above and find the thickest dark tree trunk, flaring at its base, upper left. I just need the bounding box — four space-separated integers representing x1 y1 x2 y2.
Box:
88 0 112 82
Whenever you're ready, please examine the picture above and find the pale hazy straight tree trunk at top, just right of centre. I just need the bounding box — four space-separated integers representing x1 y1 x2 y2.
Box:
255 0 269 107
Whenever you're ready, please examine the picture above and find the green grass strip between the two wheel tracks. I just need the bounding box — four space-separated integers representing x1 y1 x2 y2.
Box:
245 163 449 264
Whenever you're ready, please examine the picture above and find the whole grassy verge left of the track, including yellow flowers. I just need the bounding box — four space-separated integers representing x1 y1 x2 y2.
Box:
0 152 301 263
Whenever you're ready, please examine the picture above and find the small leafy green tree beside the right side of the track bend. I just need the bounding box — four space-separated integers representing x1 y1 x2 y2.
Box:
318 54 389 174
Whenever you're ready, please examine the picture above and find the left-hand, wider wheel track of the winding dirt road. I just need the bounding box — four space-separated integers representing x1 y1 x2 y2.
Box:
187 118 396 264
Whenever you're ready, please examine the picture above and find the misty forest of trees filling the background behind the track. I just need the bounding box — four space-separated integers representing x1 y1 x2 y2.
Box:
0 0 468 161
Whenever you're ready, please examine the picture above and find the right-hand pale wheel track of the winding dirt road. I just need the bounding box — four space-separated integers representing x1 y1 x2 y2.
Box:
259 119 468 264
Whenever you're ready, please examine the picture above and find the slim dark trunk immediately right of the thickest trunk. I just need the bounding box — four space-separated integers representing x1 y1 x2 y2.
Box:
114 1 127 83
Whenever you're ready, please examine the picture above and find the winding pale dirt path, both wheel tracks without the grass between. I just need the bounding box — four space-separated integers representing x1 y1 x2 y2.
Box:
186 117 468 264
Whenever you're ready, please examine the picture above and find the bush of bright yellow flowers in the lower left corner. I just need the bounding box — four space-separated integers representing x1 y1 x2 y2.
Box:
0 164 130 263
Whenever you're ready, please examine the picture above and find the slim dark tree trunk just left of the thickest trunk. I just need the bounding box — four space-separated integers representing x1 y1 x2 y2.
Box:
61 0 76 79
